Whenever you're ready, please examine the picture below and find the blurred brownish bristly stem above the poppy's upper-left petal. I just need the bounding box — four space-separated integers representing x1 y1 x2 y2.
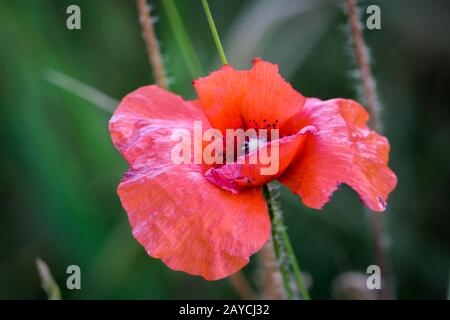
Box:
136 0 167 89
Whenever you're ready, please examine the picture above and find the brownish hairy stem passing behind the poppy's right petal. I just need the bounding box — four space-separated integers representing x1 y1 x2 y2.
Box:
347 0 395 299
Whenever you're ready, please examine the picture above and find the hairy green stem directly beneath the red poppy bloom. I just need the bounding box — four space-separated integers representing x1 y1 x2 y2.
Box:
263 185 311 300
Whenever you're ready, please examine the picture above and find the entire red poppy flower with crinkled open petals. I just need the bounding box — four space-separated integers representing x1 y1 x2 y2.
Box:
109 59 397 280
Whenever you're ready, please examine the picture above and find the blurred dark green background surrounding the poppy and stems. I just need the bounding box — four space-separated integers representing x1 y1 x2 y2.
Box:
0 0 450 299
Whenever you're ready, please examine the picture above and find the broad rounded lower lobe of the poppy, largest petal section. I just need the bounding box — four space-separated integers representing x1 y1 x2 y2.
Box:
118 166 270 280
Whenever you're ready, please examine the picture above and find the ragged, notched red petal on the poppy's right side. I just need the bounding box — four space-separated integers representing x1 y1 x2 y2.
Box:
279 98 397 212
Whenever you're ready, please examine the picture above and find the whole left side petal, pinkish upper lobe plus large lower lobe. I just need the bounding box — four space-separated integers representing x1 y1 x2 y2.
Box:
110 86 270 280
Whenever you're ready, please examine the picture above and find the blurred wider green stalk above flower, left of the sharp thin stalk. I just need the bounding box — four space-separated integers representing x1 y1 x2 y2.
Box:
162 0 203 78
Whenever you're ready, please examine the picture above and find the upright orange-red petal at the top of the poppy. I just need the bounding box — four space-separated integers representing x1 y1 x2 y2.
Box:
194 58 306 131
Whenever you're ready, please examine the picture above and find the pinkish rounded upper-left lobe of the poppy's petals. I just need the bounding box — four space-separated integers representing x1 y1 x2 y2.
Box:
109 85 210 166
